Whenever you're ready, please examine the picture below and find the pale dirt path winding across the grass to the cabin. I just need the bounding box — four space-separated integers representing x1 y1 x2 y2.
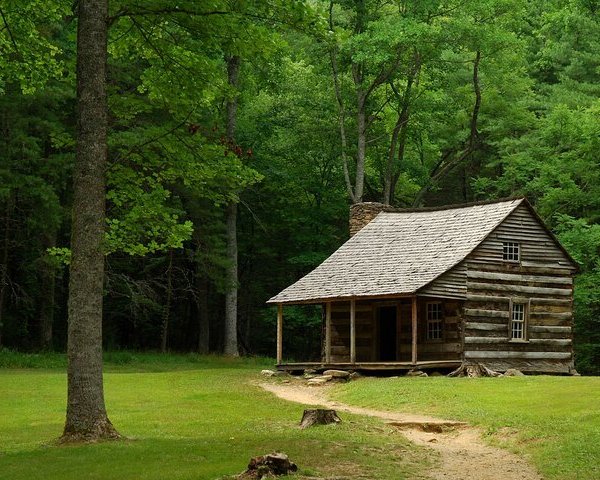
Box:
260 383 542 480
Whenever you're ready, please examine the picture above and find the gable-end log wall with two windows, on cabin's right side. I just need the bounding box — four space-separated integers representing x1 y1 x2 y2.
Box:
464 206 574 373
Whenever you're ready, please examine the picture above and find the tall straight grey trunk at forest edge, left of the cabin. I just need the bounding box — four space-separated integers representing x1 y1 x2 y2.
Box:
223 55 240 356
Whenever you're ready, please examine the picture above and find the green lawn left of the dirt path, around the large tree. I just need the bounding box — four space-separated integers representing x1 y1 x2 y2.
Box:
0 351 435 480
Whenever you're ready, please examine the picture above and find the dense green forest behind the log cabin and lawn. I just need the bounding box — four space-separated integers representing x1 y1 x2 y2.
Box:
0 0 600 374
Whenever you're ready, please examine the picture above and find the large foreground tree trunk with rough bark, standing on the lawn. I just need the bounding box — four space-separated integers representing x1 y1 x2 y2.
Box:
62 0 119 441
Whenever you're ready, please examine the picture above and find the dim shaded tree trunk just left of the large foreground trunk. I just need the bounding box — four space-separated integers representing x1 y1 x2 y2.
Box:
39 231 56 350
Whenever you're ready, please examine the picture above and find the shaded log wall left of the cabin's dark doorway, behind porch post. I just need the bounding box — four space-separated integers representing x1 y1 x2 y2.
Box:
323 301 374 363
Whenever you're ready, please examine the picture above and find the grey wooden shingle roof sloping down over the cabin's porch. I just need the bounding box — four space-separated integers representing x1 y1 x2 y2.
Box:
267 199 524 303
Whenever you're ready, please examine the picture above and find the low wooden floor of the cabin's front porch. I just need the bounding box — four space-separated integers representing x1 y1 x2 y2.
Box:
277 360 462 372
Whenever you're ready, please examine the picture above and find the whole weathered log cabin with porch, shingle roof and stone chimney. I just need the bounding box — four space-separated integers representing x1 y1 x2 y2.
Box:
267 198 578 374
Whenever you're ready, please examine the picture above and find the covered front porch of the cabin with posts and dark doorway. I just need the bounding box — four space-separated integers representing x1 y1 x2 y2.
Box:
277 295 463 371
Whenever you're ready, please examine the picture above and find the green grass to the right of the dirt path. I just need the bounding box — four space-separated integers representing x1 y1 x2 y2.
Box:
333 376 600 480
